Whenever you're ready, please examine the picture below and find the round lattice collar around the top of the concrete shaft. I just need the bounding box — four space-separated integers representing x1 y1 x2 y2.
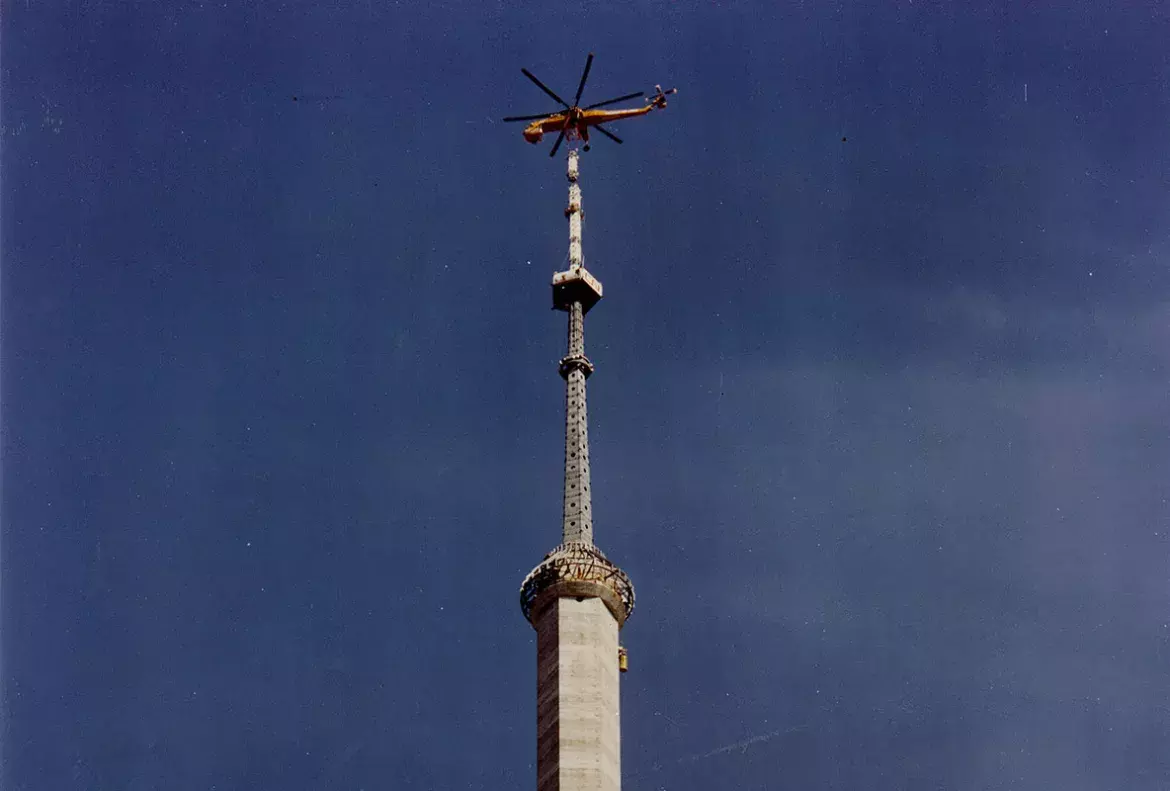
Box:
519 541 634 626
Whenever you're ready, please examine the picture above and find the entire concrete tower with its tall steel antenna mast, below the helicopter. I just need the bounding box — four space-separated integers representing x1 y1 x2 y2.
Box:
521 150 634 791
